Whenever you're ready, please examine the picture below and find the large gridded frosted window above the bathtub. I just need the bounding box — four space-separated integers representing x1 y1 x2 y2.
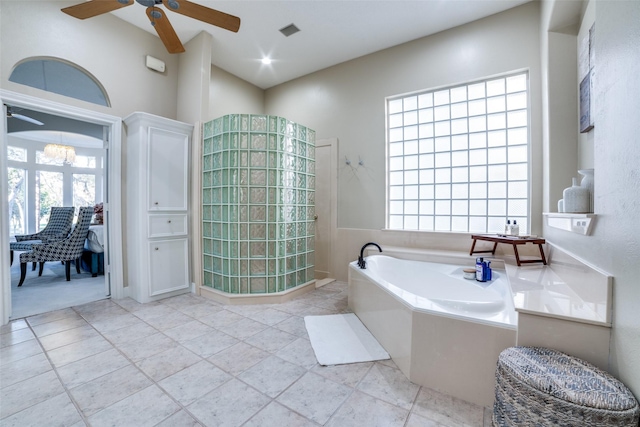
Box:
387 72 529 234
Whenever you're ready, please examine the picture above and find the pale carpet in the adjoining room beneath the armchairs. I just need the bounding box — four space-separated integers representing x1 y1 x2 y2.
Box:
11 253 107 319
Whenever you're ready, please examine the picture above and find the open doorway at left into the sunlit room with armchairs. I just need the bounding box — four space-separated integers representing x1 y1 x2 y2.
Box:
7 129 110 319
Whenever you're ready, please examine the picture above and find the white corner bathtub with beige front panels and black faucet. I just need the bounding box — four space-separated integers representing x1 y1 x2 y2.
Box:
349 254 517 406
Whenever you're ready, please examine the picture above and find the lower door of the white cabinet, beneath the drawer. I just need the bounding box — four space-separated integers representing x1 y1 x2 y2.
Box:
149 239 189 296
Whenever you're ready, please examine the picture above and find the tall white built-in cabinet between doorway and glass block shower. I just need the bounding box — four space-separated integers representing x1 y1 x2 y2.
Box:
124 113 193 303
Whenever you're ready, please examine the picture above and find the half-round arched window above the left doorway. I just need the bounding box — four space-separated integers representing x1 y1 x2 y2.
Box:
9 58 111 107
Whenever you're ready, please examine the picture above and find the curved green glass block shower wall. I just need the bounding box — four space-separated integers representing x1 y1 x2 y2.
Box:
202 114 315 294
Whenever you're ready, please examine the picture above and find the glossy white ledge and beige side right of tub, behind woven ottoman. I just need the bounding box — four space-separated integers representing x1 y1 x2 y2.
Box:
505 242 613 370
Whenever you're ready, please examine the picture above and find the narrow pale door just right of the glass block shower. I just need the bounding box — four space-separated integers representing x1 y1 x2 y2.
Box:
315 138 338 286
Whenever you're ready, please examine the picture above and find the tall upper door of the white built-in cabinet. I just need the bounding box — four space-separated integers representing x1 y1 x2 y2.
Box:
147 127 189 211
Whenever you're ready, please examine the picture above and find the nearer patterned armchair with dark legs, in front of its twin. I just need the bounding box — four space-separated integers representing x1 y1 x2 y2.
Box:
18 206 93 286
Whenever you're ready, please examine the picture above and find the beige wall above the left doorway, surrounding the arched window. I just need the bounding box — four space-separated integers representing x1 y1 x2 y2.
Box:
0 1 178 118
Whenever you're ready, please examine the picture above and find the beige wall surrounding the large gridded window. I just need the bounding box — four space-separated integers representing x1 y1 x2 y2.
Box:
265 2 542 234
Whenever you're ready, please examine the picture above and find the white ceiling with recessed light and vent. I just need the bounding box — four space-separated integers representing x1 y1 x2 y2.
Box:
111 0 531 89
